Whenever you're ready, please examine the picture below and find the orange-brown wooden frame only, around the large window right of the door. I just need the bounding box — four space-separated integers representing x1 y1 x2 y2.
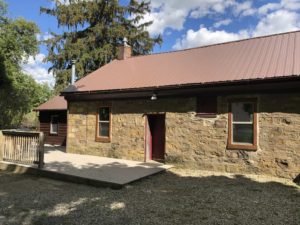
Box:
227 98 258 151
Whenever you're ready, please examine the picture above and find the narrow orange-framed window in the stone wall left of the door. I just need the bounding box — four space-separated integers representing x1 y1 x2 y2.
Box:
96 107 111 141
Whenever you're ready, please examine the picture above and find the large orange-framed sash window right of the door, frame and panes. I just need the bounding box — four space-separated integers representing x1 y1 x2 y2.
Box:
227 99 257 150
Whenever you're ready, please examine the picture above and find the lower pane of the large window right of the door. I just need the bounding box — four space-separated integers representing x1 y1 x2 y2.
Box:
232 124 253 144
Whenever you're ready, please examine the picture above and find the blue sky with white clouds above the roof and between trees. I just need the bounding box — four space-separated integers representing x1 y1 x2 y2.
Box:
6 0 300 85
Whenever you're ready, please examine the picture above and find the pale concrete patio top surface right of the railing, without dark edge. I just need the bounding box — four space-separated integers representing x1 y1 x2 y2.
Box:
43 151 171 185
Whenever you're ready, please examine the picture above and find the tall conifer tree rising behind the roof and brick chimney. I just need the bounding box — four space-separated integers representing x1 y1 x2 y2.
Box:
41 0 162 91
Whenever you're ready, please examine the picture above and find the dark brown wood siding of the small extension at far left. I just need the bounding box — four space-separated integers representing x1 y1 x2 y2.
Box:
39 110 67 145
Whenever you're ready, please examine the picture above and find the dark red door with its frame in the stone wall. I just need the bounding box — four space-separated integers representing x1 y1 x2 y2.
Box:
146 114 165 162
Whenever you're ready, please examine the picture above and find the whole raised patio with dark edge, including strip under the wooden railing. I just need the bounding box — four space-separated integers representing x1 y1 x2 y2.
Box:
0 148 172 188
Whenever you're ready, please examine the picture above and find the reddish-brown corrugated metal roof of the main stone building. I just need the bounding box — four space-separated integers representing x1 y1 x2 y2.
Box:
64 31 300 92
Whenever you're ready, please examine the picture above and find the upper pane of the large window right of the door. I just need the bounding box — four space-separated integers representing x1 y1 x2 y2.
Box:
231 102 254 122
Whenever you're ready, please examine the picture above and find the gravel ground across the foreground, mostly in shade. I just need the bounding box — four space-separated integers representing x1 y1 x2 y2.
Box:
0 169 300 225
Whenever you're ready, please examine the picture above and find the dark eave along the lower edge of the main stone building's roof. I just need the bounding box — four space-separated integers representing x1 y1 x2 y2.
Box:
61 76 300 100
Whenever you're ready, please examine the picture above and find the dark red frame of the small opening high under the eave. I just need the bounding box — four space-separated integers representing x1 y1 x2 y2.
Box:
196 95 218 118
